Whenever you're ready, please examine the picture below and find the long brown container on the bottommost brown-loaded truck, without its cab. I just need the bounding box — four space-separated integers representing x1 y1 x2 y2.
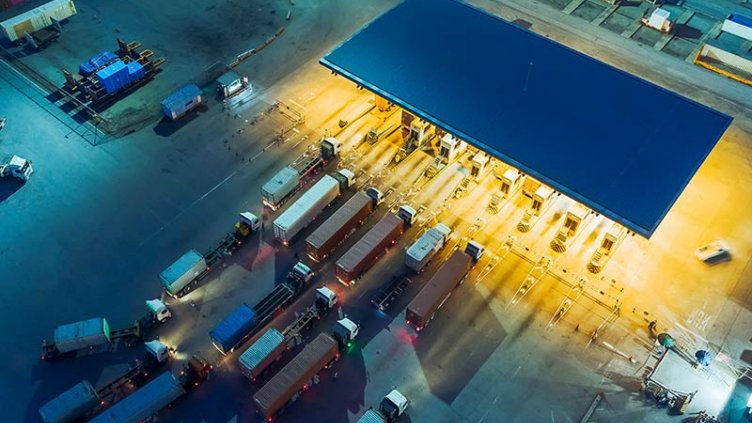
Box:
253 333 339 418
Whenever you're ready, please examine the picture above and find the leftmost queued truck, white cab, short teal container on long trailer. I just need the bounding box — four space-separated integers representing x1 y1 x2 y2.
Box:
41 299 172 360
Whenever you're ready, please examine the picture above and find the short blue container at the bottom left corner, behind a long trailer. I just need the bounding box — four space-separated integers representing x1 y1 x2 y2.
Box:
39 381 99 423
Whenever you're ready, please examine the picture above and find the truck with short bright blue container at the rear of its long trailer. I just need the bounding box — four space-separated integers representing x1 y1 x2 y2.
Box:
209 262 313 354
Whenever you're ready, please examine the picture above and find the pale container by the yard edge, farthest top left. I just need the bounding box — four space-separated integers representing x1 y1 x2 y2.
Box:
0 0 76 41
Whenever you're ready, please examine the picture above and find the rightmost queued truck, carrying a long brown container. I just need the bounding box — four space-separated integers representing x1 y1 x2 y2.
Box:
405 241 484 332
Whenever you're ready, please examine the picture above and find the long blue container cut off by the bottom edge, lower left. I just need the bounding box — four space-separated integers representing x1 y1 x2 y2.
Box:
90 371 185 423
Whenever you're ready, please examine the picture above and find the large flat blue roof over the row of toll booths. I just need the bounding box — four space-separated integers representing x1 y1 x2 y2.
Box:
321 0 731 237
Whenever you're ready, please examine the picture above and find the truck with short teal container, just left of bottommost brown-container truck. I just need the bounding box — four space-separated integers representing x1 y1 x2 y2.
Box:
238 287 337 382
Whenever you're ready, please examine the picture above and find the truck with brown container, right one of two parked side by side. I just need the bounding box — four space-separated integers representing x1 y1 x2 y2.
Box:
335 205 417 286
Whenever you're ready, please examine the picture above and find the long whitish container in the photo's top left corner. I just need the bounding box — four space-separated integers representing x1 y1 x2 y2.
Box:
0 0 77 41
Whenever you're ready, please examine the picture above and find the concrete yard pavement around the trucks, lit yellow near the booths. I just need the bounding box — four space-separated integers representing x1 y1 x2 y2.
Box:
0 1 752 422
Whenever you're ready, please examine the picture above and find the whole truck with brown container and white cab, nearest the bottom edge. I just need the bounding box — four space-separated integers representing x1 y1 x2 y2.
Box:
253 318 358 421
